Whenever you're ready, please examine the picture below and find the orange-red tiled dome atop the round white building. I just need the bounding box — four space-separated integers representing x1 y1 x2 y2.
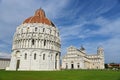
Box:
23 8 55 26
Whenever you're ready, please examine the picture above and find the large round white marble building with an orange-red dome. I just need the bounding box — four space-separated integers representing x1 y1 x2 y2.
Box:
7 8 61 71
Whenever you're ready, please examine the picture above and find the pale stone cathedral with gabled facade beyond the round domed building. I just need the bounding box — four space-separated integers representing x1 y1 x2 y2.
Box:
62 46 104 69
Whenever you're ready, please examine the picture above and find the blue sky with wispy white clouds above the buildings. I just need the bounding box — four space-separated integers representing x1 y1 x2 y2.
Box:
0 0 120 63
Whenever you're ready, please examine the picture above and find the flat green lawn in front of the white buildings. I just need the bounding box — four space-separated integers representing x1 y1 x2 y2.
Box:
0 70 120 80
